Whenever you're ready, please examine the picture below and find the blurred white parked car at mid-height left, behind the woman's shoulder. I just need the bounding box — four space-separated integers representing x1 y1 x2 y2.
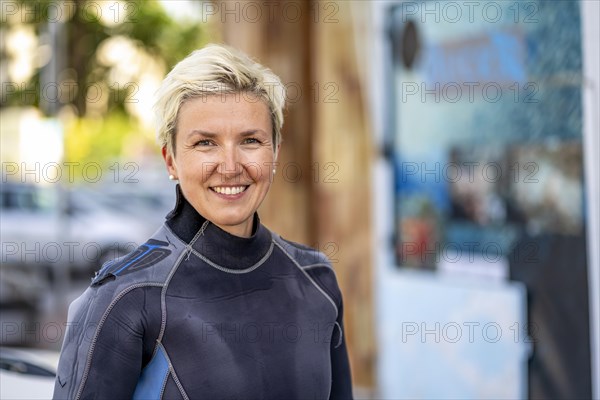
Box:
0 182 163 276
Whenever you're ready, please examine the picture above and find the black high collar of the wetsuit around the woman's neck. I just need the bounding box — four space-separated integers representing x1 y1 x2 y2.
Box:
166 185 272 269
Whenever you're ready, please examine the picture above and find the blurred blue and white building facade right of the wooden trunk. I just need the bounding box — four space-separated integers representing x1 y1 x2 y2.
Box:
373 1 599 398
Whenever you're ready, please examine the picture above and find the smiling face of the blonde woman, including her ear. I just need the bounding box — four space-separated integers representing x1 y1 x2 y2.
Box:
163 94 276 237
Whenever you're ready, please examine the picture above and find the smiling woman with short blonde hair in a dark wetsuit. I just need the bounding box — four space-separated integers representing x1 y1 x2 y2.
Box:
54 45 352 399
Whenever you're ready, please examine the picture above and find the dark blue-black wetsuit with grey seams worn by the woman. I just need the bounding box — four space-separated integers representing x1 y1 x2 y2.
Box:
54 190 352 400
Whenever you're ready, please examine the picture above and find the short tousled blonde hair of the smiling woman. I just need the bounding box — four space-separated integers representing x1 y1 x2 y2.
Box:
154 44 285 155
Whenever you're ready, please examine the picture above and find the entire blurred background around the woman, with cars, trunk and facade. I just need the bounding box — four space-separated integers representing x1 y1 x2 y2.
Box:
0 0 600 399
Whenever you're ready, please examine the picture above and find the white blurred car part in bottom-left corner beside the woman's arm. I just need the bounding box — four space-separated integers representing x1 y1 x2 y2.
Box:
0 347 59 400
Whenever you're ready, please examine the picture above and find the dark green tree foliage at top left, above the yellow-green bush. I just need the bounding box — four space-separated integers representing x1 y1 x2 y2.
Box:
0 0 206 111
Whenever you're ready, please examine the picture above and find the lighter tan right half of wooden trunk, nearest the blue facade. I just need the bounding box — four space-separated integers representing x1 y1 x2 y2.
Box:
312 1 375 387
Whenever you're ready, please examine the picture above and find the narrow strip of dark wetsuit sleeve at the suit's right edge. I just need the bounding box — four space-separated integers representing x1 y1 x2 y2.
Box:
329 294 353 400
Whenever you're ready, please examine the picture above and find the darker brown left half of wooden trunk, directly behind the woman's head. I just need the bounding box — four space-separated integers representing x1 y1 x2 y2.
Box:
215 1 317 244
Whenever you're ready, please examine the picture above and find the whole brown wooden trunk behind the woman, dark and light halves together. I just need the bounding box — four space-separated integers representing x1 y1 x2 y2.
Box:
214 0 375 387
